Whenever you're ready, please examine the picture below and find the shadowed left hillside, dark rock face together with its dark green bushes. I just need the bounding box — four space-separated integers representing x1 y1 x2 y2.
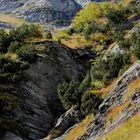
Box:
0 24 95 140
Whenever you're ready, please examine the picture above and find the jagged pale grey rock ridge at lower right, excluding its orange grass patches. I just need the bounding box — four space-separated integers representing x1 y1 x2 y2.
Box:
79 62 140 140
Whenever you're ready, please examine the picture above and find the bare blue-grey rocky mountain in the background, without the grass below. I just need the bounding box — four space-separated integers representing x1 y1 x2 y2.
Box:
0 0 81 26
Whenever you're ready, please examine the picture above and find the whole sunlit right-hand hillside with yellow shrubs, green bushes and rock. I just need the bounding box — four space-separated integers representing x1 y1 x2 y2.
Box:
44 0 140 140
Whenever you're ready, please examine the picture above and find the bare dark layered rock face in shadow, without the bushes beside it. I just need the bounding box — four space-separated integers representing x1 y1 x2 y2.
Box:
1 41 94 140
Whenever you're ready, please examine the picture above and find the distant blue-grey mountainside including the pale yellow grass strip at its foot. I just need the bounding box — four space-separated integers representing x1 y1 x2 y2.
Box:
0 0 107 29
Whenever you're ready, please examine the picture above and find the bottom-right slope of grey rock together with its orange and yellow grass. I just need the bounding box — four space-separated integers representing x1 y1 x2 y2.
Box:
79 62 140 140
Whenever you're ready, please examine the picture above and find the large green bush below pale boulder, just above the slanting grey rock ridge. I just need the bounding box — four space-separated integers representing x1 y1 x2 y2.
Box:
91 53 130 85
